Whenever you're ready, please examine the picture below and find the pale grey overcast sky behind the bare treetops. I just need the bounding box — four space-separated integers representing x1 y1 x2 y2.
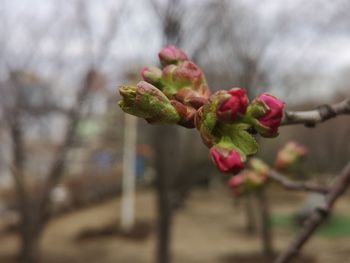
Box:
0 0 350 103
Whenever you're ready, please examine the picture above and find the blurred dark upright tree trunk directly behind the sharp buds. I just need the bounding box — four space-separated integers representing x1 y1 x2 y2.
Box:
151 0 184 263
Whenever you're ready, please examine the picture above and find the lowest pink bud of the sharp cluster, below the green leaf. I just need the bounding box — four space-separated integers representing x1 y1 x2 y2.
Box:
210 146 244 173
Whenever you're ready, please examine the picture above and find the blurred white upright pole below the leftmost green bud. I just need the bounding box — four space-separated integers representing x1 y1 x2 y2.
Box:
120 114 137 231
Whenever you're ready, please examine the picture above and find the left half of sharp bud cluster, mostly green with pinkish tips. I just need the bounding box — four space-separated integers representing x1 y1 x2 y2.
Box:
119 46 210 128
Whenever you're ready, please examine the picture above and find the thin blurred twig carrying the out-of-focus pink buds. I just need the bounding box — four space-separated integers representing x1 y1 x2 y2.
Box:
268 170 330 194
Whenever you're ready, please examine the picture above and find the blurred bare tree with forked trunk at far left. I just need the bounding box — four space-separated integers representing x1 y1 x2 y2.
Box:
1 1 124 263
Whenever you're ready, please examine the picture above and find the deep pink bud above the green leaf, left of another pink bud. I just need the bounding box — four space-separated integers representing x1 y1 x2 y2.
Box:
216 88 249 123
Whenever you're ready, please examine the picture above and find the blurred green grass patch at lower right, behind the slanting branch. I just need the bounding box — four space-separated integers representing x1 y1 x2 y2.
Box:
271 215 350 238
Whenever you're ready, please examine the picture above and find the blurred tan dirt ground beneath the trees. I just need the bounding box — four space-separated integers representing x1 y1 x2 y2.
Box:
0 189 350 263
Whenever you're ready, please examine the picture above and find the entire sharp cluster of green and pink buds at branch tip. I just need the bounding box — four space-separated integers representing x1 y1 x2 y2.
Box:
119 46 284 174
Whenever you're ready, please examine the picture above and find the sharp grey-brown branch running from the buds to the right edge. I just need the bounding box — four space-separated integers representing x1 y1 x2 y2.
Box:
281 99 350 127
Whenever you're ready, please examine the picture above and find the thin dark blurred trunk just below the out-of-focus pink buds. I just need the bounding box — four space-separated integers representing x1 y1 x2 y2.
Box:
256 188 273 257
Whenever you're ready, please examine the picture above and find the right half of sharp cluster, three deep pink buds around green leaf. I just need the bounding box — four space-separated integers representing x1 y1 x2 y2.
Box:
195 88 284 176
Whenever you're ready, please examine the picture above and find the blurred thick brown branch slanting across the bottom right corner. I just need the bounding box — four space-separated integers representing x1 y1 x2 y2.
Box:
275 162 350 263
